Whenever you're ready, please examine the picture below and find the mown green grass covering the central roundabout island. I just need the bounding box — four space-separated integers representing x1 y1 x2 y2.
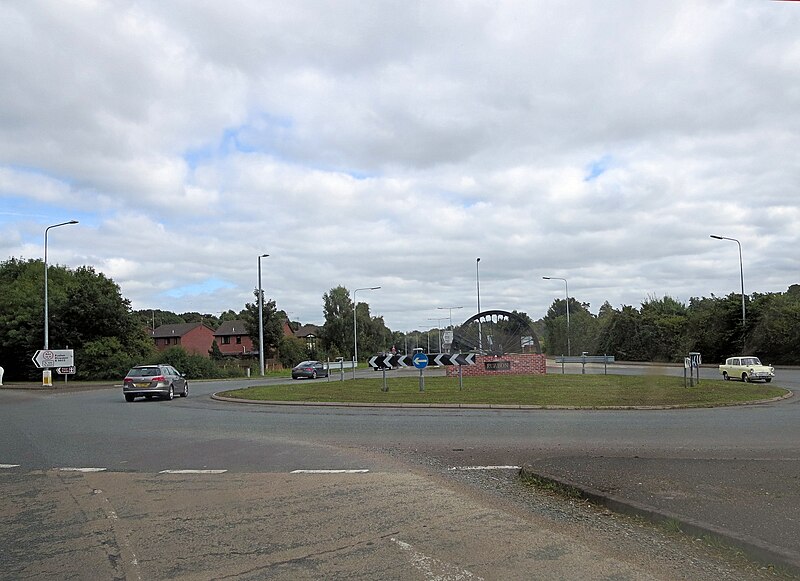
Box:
216 374 786 408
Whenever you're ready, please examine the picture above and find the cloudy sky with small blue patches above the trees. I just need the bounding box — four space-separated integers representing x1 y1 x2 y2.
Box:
0 0 800 331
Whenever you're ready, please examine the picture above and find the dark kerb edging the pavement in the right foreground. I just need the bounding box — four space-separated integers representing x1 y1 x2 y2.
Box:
519 466 800 575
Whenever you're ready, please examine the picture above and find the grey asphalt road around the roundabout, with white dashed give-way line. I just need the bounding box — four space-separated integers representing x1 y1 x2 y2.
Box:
0 366 800 579
